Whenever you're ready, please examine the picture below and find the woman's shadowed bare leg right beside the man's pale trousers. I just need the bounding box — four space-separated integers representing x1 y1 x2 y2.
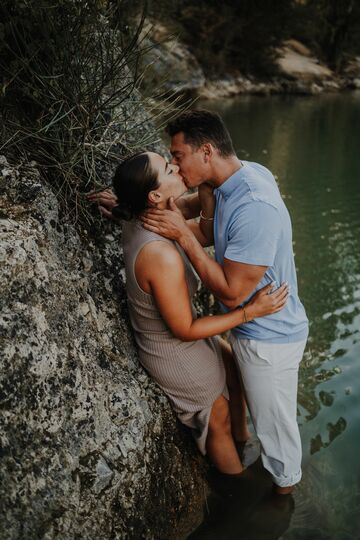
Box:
220 338 251 442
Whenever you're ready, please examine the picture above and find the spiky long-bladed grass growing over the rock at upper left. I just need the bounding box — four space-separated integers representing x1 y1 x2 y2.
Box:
0 0 176 221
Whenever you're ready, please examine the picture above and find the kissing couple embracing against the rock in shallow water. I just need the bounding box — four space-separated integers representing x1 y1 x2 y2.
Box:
88 110 308 495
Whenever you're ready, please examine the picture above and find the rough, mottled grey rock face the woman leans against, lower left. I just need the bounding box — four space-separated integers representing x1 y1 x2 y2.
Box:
0 157 204 540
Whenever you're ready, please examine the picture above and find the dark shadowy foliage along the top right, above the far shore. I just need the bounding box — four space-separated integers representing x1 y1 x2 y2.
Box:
149 0 360 76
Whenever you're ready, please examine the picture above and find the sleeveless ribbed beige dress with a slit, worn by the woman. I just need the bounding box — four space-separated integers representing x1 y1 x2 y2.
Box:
122 220 228 454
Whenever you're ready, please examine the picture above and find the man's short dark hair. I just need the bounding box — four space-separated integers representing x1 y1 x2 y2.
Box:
166 109 235 158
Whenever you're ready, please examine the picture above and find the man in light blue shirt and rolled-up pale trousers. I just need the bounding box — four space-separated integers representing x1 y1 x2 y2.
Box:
144 110 308 494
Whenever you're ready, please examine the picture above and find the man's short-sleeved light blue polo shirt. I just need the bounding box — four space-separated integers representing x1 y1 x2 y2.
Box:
214 161 308 343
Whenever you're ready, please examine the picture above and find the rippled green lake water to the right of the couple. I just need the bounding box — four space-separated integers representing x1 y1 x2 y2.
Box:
191 92 360 540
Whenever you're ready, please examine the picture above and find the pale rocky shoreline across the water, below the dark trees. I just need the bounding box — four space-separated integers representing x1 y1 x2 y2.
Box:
143 23 360 99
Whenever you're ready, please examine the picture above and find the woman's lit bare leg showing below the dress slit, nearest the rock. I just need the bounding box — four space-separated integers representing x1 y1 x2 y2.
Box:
206 396 243 474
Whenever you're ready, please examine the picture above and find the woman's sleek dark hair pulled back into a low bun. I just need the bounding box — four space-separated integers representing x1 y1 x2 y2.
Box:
112 152 160 220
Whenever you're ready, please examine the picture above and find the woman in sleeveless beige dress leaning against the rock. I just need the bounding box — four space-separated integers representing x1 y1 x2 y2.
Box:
90 152 287 474
